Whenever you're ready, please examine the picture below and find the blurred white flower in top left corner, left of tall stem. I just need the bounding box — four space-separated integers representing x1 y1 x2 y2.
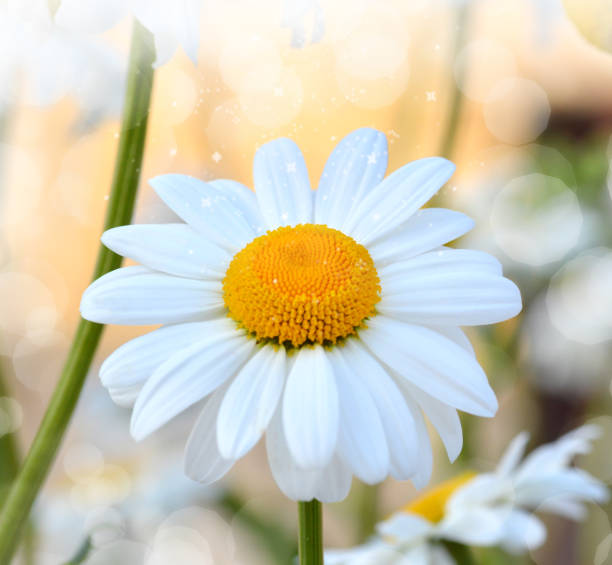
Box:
0 2 125 126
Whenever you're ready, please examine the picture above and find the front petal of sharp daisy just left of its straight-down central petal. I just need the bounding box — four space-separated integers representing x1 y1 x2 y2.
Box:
217 346 286 459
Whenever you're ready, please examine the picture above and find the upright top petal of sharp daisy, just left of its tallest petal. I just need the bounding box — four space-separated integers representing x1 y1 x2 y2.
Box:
253 138 313 229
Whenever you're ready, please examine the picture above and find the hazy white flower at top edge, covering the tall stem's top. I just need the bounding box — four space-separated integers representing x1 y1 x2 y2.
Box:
55 0 203 67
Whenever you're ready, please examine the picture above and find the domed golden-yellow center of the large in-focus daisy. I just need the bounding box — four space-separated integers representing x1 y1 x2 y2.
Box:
223 224 380 347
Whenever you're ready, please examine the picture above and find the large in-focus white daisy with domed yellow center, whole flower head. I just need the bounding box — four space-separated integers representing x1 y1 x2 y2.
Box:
81 129 521 502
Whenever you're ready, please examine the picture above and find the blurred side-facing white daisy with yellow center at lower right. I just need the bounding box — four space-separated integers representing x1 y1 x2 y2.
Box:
325 426 608 565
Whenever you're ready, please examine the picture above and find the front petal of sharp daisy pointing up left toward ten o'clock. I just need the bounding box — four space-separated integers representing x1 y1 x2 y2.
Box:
149 175 256 253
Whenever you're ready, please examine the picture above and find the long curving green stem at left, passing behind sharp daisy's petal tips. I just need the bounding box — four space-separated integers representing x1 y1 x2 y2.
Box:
0 21 155 563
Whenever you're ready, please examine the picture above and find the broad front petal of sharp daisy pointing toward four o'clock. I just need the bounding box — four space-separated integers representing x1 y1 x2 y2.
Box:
361 316 497 416
